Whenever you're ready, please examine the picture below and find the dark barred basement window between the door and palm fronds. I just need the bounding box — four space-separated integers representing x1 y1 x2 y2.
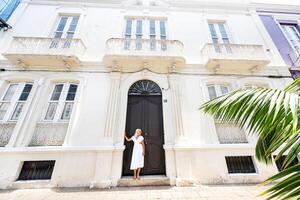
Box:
225 156 256 174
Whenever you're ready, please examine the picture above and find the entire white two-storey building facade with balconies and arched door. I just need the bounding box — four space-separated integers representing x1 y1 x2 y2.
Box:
0 0 300 188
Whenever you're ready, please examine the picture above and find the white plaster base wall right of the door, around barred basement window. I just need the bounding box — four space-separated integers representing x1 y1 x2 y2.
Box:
175 145 277 183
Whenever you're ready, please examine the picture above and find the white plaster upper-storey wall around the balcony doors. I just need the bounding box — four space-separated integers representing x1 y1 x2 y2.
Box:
0 1 284 66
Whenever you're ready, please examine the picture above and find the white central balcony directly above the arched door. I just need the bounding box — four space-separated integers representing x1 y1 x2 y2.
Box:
103 38 185 72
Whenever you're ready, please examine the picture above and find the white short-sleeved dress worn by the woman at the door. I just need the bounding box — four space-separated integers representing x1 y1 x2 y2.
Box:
130 136 144 170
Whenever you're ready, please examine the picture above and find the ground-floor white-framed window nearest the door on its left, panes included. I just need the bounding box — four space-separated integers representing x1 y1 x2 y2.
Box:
44 83 78 121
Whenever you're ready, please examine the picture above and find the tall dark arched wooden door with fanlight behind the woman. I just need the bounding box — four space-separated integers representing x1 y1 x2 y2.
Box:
122 80 165 176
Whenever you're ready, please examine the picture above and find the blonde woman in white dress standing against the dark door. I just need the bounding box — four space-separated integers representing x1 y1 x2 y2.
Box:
124 129 145 180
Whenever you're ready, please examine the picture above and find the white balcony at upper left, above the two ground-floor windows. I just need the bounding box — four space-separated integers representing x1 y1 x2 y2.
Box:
3 37 85 68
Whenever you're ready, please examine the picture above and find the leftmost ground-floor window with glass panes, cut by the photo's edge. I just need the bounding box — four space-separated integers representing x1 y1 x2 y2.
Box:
0 83 32 121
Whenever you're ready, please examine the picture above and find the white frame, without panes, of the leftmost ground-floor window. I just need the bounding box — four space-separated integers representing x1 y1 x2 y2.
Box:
0 82 33 123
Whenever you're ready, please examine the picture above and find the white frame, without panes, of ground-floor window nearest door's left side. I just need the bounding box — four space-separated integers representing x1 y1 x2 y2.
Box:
42 82 79 122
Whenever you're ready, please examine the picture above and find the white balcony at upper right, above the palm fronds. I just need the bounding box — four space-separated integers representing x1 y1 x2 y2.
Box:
202 43 270 71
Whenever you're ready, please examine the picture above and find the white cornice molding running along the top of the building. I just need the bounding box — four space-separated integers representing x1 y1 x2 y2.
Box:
23 0 300 13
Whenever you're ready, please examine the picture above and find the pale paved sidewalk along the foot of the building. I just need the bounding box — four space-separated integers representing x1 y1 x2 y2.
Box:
0 185 266 200
